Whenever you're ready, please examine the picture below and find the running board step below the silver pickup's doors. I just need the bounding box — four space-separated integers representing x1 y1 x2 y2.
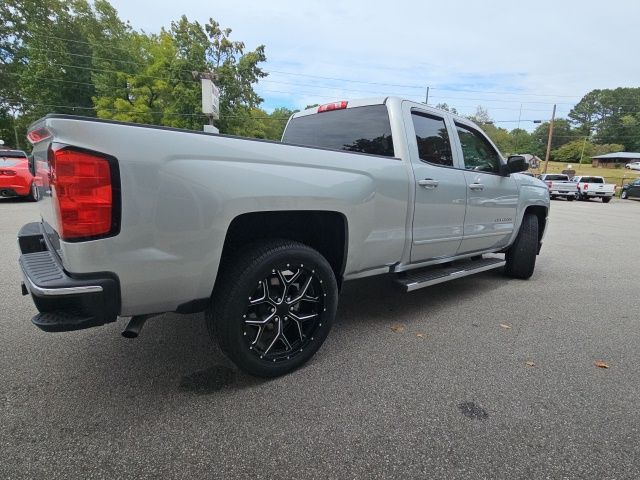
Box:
395 257 506 292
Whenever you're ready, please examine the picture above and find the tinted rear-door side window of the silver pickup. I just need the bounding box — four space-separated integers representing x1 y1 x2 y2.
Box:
411 113 453 167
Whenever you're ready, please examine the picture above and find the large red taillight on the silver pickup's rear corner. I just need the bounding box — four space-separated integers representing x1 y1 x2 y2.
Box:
50 148 116 240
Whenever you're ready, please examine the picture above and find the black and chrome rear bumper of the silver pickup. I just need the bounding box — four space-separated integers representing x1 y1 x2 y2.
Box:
18 223 120 332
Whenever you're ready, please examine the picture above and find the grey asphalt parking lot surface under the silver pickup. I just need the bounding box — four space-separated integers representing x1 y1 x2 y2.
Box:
0 200 640 479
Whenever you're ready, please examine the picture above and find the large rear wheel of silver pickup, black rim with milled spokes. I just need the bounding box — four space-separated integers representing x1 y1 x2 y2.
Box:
206 240 338 377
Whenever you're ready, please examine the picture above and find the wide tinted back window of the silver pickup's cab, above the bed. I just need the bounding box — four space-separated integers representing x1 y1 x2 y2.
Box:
282 105 394 157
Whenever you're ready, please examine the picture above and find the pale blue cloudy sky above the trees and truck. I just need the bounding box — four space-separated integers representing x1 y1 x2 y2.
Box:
111 0 640 130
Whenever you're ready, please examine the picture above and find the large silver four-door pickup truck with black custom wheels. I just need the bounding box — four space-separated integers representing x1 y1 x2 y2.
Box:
18 97 549 376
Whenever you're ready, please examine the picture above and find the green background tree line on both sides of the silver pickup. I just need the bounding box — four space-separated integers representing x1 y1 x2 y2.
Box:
0 0 640 162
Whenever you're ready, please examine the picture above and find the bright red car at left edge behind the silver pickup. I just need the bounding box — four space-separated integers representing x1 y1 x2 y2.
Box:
0 150 40 201
